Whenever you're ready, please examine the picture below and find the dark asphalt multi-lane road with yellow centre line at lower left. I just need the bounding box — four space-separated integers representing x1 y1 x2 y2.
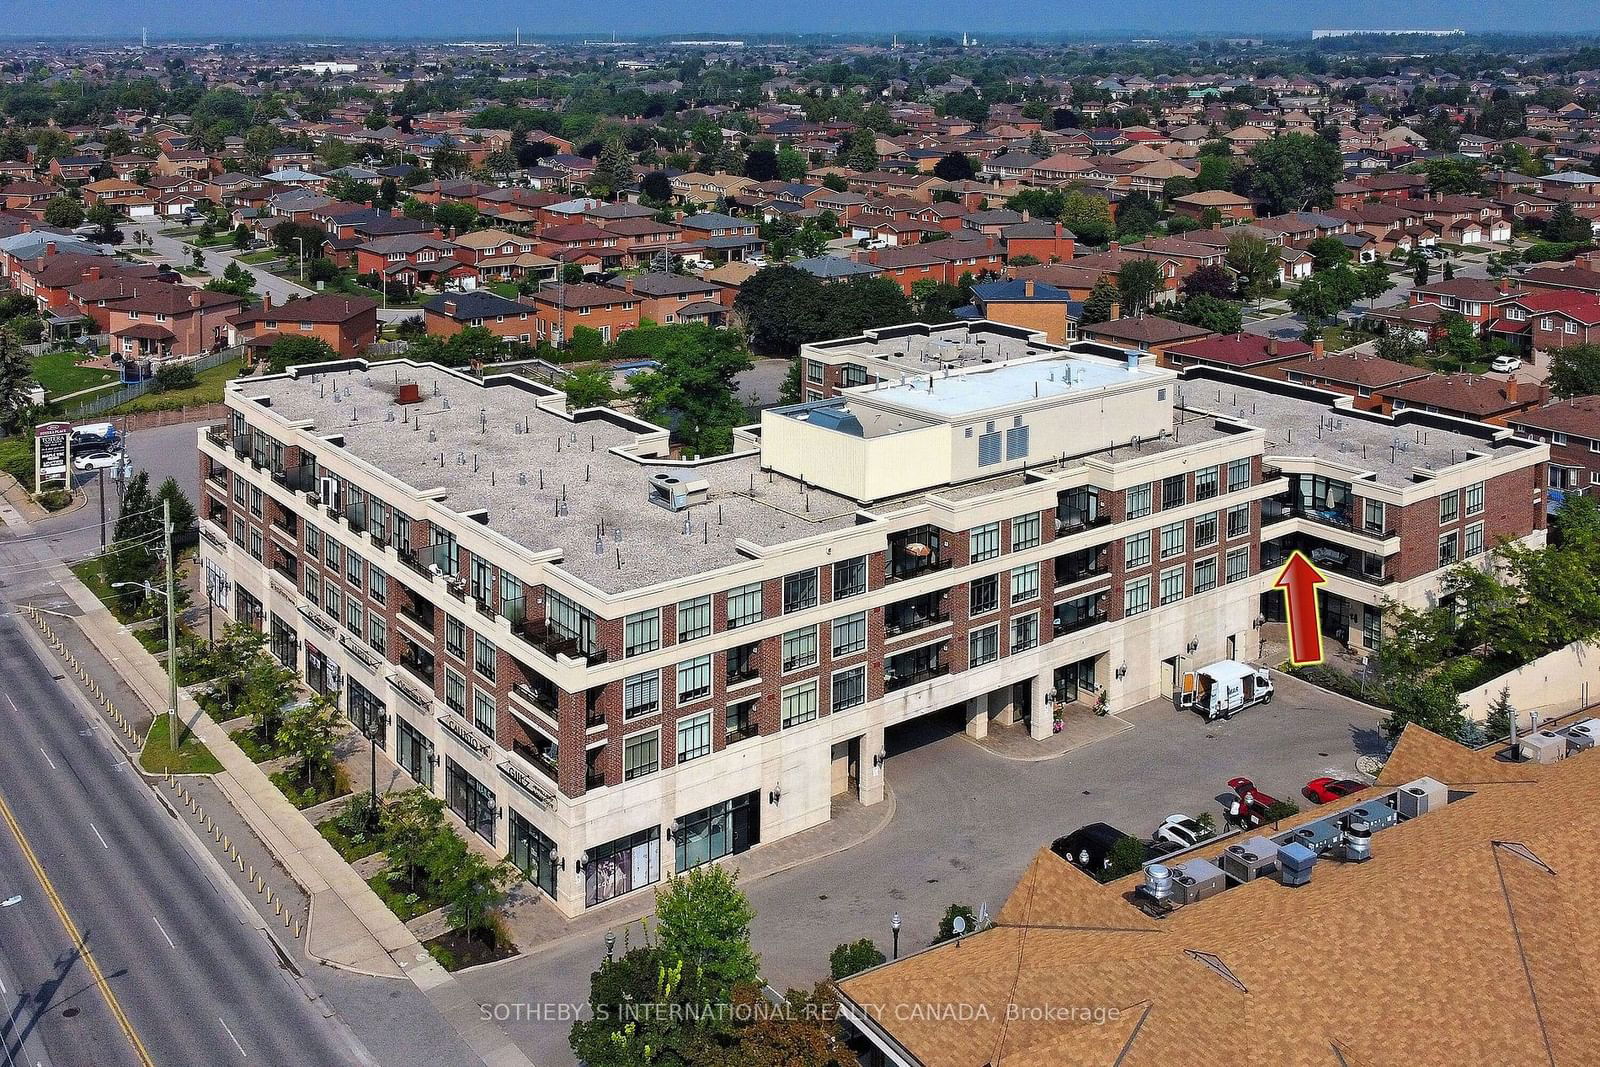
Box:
0 613 374 1067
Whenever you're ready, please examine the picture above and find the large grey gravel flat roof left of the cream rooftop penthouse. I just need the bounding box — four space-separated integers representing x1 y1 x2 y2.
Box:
242 362 856 593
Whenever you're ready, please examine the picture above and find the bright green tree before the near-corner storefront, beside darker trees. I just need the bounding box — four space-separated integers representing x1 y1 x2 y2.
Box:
656 865 760 1005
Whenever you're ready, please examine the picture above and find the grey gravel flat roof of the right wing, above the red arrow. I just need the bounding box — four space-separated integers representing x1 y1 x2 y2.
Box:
1178 378 1522 488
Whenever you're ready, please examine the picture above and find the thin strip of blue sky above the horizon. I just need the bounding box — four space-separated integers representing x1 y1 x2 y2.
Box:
9 0 1600 38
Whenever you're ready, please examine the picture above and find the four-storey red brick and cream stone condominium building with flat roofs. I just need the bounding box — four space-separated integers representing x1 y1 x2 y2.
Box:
200 322 1547 915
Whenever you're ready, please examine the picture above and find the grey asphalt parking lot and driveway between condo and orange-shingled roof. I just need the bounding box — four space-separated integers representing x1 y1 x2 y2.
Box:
464 675 1381 1064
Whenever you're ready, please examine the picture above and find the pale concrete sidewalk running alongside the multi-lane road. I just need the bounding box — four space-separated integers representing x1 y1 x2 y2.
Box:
0 502 531 1067
